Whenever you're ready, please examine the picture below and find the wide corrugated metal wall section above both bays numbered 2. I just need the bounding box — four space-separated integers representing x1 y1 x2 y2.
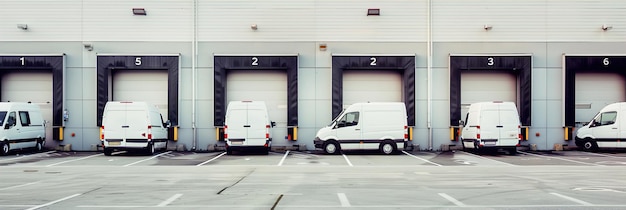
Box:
199 0 426 41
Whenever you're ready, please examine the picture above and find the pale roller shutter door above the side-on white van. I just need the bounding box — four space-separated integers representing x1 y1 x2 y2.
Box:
343 70 403 108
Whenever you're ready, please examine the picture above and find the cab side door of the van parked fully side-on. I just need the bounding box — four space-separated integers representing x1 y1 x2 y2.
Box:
333 112 362 149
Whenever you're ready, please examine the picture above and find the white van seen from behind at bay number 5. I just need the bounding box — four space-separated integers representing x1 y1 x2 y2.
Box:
100 101 169 156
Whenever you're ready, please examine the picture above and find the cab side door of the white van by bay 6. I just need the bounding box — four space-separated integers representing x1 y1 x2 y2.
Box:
589 111 619 148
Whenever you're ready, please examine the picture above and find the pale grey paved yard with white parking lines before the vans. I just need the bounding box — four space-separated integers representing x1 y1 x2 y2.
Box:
0 151 626 209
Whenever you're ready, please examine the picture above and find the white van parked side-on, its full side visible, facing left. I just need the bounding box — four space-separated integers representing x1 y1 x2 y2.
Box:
313 102 408 154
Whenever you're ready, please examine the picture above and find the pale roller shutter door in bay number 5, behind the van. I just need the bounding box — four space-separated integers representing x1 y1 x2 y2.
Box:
111 70 168 121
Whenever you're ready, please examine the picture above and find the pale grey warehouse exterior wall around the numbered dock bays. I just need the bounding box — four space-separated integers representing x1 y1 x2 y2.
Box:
0 0 626 150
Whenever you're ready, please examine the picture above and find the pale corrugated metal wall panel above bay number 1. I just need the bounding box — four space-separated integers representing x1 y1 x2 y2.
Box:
0 0 82 41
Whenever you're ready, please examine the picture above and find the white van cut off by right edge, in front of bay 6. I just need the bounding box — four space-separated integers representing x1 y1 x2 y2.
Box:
574 102 626 151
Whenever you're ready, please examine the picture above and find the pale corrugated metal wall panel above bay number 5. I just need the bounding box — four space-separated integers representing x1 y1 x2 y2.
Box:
82 0 193 41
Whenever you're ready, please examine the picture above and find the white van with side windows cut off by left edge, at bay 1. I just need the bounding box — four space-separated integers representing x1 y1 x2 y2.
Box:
0 102 46 155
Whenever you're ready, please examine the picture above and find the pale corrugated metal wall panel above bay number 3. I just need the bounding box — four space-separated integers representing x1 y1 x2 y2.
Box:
433 0 546 41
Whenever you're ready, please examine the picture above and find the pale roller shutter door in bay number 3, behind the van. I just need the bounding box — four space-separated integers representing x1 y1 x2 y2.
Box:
461 72 519 120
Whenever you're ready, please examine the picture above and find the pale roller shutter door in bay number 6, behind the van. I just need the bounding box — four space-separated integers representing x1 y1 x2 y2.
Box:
574 73 626 127
